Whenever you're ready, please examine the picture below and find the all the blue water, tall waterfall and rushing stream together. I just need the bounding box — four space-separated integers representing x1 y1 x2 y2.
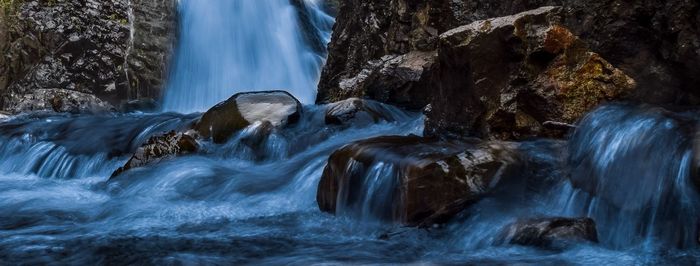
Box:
0 0 700 265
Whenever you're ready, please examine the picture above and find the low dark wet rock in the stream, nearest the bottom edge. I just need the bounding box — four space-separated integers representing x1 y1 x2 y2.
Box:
503 218 598 248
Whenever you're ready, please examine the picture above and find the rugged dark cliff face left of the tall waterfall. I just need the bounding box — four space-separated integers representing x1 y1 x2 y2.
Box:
0 0 177 112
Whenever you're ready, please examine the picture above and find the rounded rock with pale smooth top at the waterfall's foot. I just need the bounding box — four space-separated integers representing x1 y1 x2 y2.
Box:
194 91 302 143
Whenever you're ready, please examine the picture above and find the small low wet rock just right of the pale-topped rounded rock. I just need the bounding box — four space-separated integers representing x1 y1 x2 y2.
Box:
325 98 407 126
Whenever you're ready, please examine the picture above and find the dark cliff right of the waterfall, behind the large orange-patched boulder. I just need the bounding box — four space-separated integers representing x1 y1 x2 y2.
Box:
317 0 700 138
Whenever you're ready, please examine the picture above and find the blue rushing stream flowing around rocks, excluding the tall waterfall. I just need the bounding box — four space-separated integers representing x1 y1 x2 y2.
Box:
0 105 700 265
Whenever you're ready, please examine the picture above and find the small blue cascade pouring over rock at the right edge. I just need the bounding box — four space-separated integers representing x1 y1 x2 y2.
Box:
560 105 700 248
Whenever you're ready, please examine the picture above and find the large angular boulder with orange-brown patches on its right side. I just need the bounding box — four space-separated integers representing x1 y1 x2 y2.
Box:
426 7 636 140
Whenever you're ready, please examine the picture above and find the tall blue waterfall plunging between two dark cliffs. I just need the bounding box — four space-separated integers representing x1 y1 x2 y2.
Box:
163 0 333 113
